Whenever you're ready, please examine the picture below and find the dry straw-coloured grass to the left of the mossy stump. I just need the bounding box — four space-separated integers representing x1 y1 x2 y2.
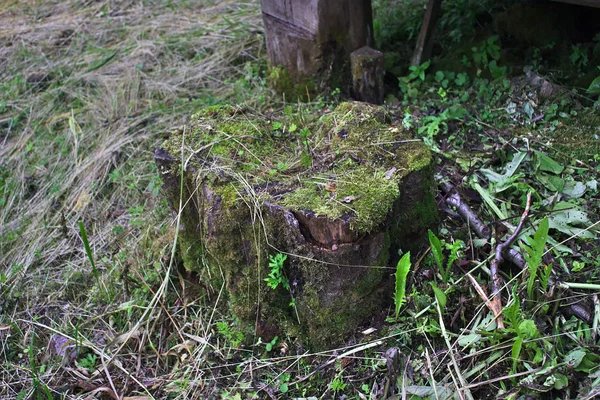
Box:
0 0 276 398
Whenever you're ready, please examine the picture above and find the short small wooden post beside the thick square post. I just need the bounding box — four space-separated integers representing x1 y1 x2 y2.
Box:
350 46 385 104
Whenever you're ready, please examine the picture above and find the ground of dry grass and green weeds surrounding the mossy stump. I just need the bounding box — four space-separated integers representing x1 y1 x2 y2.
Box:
0 0 600 400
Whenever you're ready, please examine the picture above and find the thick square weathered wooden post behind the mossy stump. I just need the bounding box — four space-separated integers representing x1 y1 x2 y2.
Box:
261 0 373 95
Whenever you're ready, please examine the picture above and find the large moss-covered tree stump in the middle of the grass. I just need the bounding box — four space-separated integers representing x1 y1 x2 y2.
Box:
155 103 437 348
